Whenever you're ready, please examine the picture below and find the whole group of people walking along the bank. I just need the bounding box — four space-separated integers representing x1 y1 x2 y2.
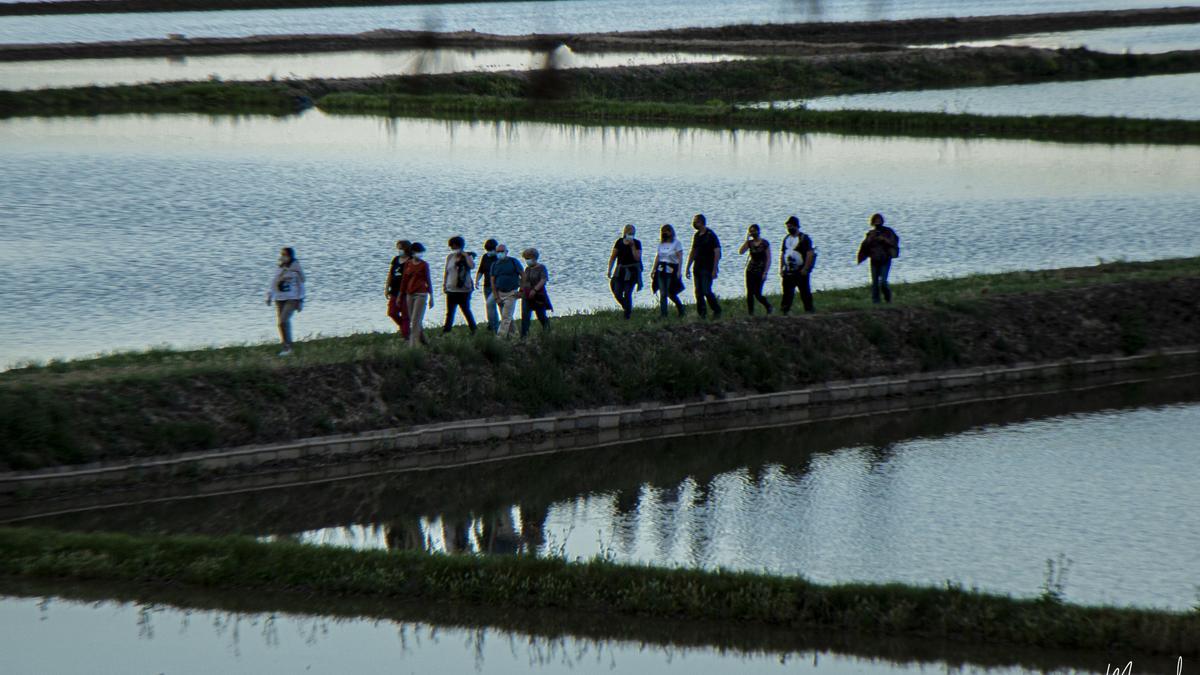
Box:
266 214 900 356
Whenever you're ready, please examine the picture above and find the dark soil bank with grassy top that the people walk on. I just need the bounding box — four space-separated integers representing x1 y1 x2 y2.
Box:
0 277 1200 470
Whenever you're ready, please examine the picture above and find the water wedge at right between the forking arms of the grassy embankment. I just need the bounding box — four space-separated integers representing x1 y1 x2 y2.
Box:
758 73 1200 120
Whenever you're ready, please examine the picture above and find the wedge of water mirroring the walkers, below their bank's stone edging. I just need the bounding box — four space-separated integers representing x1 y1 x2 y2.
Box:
16 376 1200 610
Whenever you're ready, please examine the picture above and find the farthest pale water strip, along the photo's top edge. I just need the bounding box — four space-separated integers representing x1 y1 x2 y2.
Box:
0 0 1192 43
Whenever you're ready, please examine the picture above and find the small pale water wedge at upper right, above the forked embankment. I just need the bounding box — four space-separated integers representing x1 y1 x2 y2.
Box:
936 24 1200 54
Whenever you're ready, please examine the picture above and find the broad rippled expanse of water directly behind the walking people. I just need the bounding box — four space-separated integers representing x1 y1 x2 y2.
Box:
0 112 1200 366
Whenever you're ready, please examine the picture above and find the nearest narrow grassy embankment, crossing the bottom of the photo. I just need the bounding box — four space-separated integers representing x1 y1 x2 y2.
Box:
0 528 1200 657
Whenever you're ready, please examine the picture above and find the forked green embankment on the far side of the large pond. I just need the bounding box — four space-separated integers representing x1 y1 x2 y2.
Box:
7 48 1200 143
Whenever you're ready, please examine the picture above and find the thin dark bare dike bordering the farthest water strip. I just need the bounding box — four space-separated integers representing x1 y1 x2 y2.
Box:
0 5 1200 61
